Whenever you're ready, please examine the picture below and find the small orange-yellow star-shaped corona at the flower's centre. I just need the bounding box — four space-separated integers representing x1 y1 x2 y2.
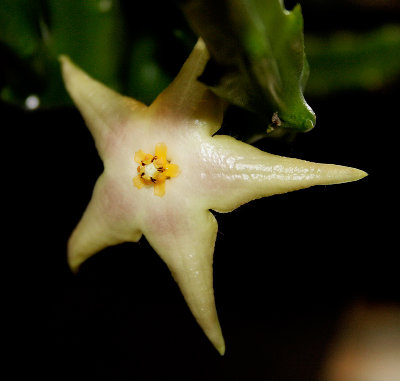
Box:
133 143 179 197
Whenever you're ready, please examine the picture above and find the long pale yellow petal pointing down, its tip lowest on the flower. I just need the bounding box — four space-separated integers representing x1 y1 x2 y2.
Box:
144 208 225 355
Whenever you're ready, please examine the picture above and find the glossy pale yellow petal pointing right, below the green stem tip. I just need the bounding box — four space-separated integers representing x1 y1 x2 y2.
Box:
199 136 367 212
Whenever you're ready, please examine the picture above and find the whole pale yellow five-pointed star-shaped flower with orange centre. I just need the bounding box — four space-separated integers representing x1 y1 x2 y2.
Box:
60 40 366 354
